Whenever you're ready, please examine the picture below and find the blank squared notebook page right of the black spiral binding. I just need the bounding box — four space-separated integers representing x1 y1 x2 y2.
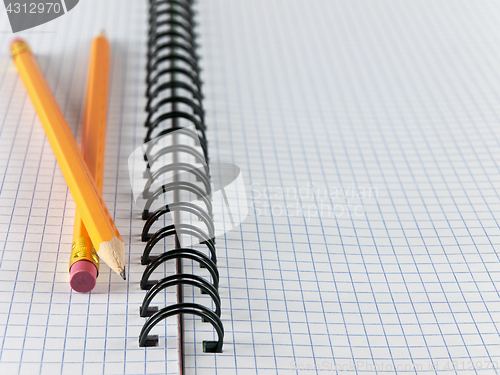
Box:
187 0 500 375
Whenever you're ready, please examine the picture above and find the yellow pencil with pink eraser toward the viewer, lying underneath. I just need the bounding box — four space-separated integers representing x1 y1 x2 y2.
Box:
69 33 110 293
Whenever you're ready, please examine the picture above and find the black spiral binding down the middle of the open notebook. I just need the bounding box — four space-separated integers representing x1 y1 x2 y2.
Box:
139 0 224 362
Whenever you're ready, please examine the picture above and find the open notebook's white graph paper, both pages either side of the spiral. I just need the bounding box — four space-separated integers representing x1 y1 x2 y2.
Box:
0 0 500 375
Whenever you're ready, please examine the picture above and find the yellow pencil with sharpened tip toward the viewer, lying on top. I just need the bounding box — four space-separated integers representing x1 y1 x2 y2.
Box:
10 39 125 279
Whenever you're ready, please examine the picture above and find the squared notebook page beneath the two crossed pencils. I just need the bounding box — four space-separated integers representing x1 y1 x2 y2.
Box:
0 0 178 375
